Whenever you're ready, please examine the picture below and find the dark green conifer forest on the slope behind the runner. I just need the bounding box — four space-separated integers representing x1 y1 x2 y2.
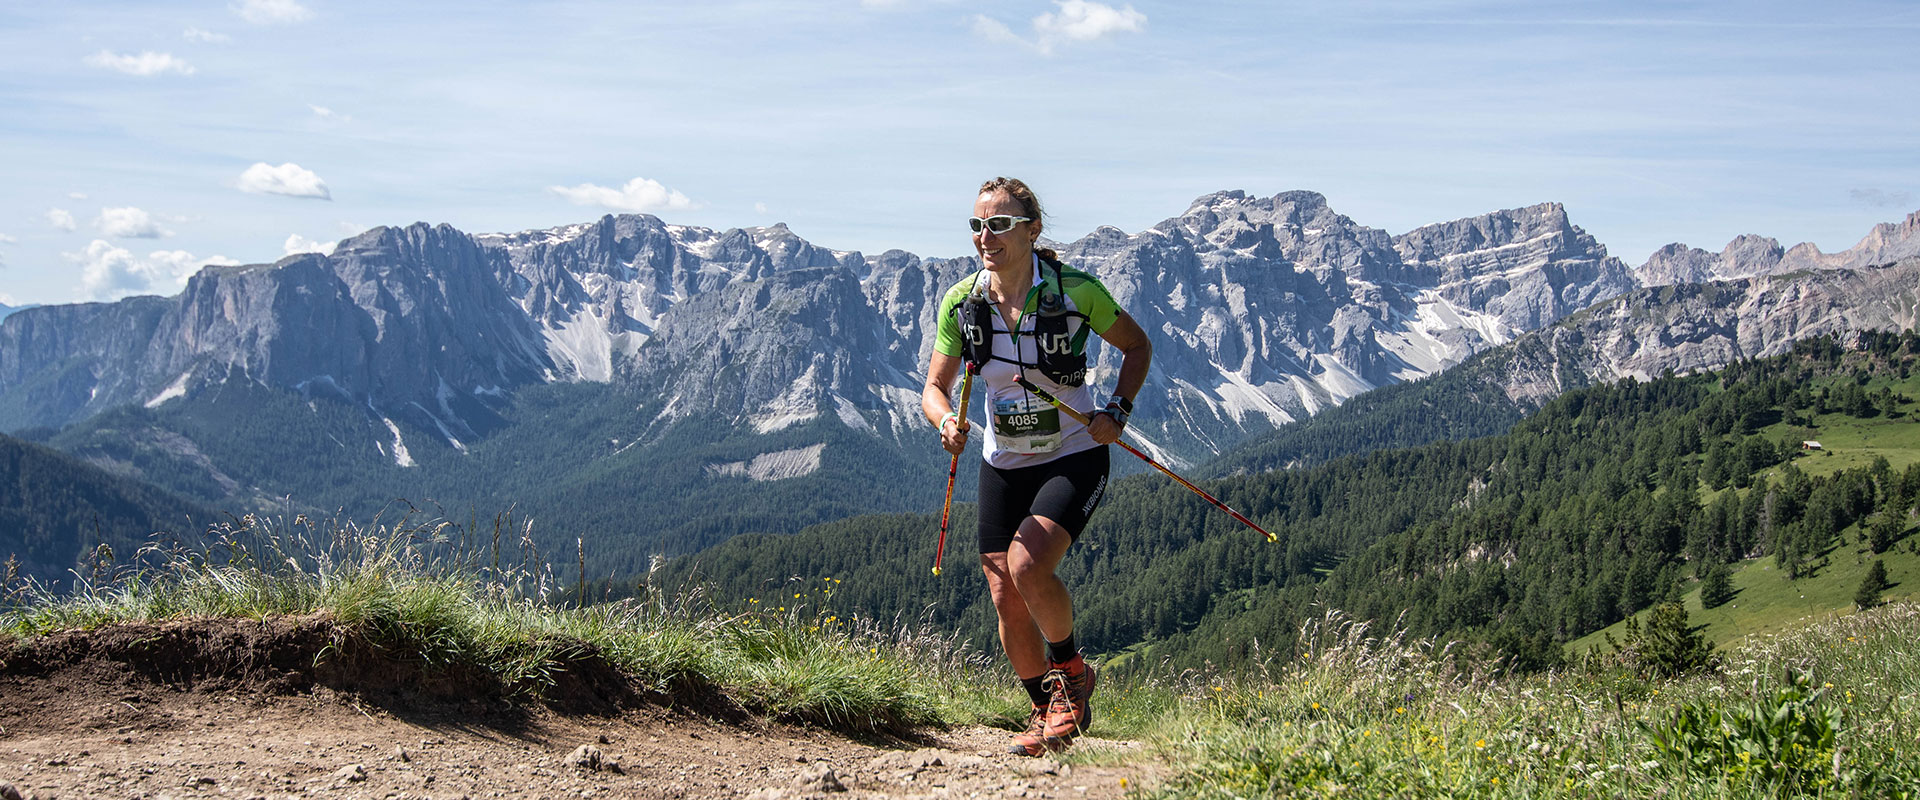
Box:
655 332 1920 668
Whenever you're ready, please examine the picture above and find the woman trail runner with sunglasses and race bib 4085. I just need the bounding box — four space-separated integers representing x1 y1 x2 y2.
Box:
920 178 1154 756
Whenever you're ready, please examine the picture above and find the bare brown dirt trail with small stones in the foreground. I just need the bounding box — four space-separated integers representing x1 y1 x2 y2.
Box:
0 622 1148 800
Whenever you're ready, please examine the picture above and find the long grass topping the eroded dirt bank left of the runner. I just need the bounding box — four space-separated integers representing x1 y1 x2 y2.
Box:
0 516 1008 729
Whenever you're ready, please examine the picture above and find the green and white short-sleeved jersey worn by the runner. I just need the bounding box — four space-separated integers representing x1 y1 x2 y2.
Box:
933 255 1119 468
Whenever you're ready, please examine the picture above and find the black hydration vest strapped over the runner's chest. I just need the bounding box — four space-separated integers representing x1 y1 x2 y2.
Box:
954 257 1092 386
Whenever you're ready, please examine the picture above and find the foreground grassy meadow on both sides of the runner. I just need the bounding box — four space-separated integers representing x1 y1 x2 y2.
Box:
0 506 1920 798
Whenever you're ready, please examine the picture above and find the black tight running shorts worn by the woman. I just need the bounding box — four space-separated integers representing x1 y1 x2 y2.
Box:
979 447 1108 553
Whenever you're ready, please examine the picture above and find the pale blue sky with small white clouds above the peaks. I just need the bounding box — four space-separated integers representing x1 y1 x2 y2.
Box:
0 0 1920 305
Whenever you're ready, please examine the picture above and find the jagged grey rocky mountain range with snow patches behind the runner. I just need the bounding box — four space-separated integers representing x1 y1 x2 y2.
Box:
0 192 1920 529
